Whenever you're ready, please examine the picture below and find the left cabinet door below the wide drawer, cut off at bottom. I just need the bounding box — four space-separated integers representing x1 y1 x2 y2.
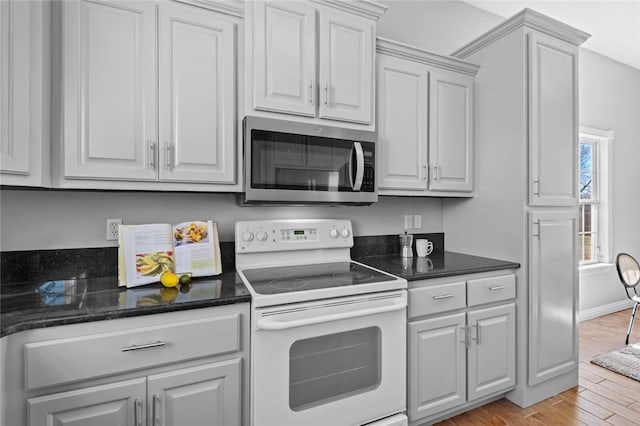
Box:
27 378 146 426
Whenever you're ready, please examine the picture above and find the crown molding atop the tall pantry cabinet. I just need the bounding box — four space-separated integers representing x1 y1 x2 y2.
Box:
452 8 591 58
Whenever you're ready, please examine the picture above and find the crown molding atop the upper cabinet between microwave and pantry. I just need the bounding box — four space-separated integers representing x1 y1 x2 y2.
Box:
376 37 480 77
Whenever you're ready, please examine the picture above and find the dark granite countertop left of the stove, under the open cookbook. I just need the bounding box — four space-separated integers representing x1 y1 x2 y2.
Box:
0 271 251 336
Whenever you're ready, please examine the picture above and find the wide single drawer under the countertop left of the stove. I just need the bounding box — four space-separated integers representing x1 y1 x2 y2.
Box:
25 313 240 390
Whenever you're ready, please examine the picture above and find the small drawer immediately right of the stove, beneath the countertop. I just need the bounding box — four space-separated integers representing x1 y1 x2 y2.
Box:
408 281 466 318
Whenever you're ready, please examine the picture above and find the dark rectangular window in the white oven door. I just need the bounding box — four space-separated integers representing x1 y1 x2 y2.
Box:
289 327 381 411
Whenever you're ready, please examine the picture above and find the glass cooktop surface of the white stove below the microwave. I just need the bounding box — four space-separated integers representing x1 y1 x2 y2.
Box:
242 262 397 294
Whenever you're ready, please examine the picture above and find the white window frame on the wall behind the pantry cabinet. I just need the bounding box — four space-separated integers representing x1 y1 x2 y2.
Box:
578 126 614 269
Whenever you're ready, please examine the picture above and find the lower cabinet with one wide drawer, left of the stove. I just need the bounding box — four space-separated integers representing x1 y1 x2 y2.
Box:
0 304 249 426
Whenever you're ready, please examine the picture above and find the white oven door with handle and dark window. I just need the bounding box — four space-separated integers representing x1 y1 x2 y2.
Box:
251 290 407 426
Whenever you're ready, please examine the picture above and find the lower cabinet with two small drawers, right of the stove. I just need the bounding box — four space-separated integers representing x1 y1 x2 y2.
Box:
407 274 516 424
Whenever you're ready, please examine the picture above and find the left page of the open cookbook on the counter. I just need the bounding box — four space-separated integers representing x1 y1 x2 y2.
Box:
118 223 175 287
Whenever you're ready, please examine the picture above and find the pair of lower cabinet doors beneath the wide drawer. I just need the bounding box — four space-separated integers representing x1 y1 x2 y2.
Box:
27 359 240 426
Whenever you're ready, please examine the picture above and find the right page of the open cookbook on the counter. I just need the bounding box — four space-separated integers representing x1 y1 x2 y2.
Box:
173 220 222 277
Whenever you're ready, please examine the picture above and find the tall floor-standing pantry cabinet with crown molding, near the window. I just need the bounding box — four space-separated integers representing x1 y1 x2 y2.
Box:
443 9 588 406
